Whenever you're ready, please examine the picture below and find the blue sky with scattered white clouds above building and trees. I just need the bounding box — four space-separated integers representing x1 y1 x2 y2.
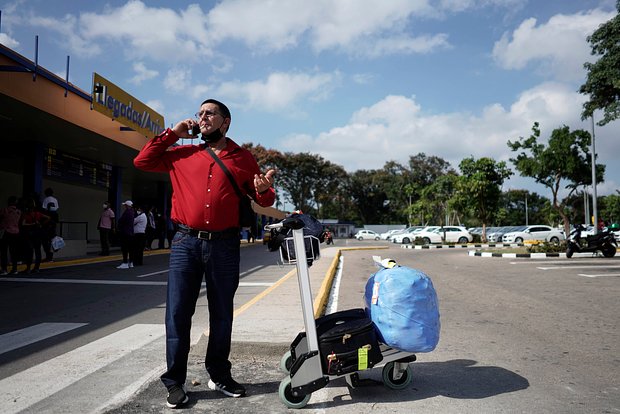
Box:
0 0 620 197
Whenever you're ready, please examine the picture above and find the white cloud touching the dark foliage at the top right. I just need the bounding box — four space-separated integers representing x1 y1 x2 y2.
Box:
493 9 615 81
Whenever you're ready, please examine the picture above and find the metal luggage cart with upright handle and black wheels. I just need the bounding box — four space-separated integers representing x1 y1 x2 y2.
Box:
265 217 416 408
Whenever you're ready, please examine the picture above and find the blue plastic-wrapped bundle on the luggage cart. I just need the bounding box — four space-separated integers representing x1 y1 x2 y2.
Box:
364 266 440 352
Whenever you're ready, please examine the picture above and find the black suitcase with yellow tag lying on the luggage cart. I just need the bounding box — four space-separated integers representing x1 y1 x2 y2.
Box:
316 309 383 375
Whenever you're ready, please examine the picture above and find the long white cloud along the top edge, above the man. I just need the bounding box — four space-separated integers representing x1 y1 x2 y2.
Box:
209 0 446 57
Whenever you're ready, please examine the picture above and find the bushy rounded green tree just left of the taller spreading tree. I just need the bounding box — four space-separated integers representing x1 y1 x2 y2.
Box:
452 157 513 241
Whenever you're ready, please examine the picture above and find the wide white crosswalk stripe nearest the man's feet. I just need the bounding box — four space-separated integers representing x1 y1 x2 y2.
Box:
0 324 165 413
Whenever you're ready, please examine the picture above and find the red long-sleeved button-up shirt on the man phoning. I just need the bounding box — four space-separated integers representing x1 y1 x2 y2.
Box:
134 128 275 231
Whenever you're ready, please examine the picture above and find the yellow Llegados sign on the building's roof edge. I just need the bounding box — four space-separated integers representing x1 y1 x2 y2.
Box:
93 73 165 138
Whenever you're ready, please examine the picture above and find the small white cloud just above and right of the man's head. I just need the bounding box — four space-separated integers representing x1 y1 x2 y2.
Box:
217 72 341 116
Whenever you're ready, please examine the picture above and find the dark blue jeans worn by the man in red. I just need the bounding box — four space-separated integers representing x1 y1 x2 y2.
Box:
161 232 240 387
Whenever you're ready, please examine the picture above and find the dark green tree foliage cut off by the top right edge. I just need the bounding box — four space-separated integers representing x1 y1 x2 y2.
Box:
579 0 620 126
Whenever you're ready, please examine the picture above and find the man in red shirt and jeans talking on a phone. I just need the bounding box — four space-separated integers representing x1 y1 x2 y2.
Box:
134 99 275 408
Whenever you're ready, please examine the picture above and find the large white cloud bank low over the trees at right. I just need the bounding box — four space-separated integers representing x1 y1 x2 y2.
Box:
279 83 620 196
